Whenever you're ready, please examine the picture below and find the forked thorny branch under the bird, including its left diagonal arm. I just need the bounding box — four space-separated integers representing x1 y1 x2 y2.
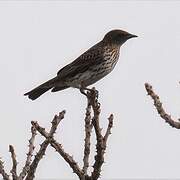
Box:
32 88 113 180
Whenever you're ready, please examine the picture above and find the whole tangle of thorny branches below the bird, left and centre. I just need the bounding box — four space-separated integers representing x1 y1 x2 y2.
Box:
0 88 113 180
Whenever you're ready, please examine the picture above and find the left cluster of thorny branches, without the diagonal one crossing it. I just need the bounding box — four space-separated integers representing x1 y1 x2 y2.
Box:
0 111 65 180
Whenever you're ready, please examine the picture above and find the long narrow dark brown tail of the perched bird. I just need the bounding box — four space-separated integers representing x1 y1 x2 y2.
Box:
24 77 67 100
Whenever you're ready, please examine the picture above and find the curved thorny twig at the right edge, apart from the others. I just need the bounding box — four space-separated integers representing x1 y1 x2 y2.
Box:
145 83 180 129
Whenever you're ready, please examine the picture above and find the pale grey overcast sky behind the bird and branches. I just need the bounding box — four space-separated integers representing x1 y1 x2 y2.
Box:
0 1 180 179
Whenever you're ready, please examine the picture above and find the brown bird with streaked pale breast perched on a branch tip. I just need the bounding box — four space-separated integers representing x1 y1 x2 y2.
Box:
24 29 138 100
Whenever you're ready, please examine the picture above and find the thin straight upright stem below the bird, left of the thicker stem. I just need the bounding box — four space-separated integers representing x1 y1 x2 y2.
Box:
82 99 93 175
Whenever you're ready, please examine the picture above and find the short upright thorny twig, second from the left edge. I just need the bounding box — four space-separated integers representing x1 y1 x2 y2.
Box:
9 145 18 180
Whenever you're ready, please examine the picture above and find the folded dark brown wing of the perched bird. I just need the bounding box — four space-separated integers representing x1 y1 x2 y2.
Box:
57 44 103 78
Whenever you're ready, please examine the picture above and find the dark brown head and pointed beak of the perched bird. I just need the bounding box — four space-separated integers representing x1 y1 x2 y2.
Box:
103 29 138 45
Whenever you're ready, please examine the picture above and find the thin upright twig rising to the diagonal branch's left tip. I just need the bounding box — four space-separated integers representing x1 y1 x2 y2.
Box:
18 126 36 180
